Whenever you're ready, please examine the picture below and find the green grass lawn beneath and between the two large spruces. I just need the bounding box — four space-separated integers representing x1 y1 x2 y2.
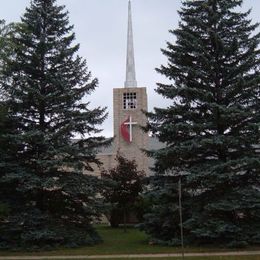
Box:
0 226 260 260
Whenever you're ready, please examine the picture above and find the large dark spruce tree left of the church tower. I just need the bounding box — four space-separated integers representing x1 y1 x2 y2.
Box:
0 0 107 248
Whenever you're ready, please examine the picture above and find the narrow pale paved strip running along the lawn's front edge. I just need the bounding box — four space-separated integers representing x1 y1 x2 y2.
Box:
0 251 260 260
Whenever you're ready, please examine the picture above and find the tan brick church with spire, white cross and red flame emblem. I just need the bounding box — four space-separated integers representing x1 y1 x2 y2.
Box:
91 0 160 176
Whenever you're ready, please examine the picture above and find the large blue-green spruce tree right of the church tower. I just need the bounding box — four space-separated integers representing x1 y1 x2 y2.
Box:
143 0 260 246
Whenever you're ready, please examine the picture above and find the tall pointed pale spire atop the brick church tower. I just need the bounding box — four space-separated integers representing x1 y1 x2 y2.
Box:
125 0 137 88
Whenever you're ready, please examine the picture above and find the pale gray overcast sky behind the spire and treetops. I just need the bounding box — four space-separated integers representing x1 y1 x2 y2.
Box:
0 0 260 136
